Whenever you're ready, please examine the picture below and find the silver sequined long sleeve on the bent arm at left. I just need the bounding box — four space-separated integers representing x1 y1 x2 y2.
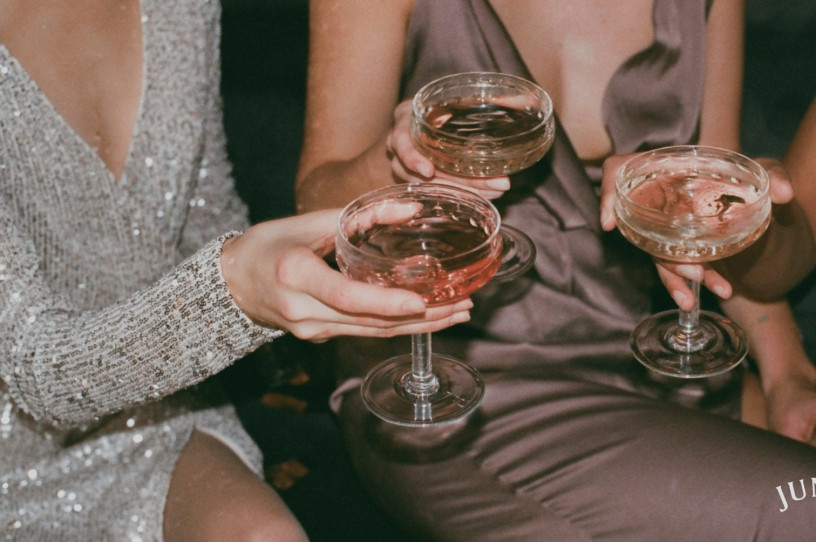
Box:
0 201 281 427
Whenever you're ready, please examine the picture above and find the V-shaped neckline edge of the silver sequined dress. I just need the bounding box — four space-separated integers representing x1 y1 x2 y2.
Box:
0 0 148 183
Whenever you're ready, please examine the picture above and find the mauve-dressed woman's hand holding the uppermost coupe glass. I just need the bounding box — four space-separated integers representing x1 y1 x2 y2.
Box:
386 100 510 199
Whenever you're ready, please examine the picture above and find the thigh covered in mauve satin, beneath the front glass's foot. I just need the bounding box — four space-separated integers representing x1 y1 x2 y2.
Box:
341 375 816 541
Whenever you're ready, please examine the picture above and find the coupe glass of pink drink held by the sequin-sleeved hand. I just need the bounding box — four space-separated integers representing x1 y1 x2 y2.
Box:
335 183 501 426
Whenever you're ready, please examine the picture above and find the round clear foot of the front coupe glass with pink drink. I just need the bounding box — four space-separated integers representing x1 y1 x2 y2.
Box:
360 354 484 427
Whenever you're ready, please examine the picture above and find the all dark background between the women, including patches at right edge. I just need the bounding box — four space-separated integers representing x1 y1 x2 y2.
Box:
215 0 816 542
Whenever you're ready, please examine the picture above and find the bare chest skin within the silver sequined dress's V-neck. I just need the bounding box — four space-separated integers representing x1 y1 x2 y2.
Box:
0 0 142 176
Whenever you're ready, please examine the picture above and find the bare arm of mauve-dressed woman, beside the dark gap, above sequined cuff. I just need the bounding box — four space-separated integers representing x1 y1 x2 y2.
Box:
295 0 412 212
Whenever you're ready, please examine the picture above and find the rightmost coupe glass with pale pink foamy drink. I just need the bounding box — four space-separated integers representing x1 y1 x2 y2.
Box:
615 145 771 378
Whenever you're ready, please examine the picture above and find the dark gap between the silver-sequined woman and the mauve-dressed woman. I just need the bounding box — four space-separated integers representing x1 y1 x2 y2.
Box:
222 0 412 542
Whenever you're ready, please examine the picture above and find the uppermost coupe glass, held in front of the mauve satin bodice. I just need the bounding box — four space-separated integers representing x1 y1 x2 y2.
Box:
411 72 555 280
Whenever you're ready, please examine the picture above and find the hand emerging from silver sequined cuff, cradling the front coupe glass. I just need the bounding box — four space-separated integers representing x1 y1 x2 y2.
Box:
221 210 472 342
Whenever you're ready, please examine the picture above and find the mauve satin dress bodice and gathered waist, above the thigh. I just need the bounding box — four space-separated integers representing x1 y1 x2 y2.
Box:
332 0 712 394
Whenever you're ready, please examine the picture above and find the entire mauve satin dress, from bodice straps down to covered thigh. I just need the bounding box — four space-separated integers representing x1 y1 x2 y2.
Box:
332 0 816 542
